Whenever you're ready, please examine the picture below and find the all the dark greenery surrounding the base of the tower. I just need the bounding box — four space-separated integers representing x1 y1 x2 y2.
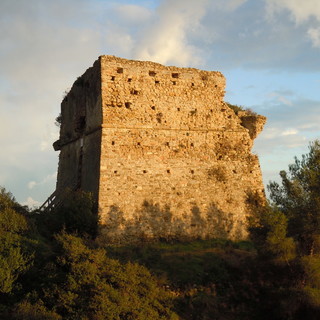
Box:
6 141 320 320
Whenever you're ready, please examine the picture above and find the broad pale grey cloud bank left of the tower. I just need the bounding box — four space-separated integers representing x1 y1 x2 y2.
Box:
0 0 100 201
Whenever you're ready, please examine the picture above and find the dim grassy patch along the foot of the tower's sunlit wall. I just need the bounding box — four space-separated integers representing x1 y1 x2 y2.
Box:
107 239 255 289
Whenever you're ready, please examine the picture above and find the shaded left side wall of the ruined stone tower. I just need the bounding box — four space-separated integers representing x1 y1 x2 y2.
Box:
54 61 102 196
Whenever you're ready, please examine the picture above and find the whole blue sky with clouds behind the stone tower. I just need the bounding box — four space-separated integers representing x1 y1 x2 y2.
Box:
0 0 320 206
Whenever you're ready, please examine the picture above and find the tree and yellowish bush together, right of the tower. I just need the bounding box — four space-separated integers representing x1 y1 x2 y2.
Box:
250 141 320 319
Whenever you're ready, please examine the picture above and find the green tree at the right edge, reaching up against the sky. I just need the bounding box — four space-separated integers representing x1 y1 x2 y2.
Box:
268 140 320 255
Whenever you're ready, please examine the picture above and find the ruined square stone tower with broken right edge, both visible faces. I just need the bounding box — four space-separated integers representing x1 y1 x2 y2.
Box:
54 56 265 241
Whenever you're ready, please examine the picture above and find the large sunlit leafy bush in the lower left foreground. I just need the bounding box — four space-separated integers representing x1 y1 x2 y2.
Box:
30 232 174 320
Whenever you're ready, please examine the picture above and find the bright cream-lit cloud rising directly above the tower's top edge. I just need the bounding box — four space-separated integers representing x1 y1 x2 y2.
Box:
134 0 208 66
